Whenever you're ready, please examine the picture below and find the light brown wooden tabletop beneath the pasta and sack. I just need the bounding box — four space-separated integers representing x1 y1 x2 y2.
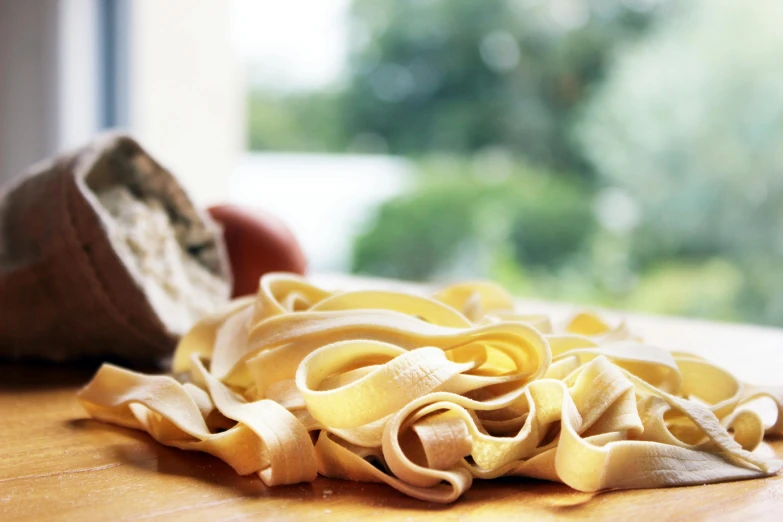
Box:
0 280 783 521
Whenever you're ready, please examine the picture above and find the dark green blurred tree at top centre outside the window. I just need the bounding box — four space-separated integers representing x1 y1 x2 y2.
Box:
250 0 661 174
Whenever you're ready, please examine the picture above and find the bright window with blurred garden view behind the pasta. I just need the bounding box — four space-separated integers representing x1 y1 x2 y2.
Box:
6 0 783 325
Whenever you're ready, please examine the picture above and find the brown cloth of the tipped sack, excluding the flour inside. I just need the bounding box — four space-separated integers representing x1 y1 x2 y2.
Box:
0 134 231 364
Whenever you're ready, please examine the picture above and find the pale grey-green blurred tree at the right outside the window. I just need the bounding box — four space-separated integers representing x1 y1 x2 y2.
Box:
577 0 783 324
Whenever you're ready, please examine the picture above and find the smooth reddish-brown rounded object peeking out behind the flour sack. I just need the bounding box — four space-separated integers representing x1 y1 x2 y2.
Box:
208 205 307 297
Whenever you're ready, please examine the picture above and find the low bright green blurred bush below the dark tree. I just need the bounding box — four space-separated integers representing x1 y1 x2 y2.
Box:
352 159 595 280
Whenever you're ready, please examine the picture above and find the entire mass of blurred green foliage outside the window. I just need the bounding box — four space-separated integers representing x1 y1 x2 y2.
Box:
245 0 783 325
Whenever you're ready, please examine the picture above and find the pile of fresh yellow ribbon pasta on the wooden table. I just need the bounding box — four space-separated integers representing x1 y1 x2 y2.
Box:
79 273 783 503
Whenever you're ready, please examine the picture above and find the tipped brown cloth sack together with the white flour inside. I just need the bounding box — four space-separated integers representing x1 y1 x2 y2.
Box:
0 134 231 364
